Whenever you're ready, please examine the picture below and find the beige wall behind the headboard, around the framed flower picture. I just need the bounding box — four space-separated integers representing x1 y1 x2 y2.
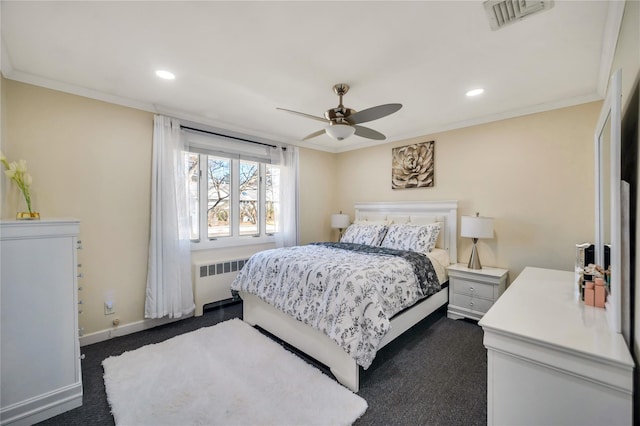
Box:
338 102 601 279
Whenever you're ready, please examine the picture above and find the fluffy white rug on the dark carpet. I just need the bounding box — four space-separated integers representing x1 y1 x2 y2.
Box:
102 319 367 426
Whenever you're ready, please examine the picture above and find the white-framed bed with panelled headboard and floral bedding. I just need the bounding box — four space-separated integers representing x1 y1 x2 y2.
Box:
232 201 457 392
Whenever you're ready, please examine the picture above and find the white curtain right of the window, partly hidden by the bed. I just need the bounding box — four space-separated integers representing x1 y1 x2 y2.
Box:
271 146 299 247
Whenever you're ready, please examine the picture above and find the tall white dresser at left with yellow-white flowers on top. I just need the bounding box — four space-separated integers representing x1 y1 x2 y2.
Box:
0 220 82 425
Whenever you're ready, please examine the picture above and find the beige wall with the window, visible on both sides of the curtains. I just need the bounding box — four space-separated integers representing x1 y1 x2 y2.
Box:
0 78 336 340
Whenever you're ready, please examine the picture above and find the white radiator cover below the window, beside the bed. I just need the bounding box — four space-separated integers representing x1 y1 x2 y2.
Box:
193 259 247 316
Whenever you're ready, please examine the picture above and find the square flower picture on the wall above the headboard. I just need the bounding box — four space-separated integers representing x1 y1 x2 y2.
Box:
391 141 435 189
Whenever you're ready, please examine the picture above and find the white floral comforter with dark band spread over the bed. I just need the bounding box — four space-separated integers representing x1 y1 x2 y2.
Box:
231 243 441 369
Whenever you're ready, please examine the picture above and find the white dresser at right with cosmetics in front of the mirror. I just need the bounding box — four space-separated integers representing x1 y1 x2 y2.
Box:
479 268 634 425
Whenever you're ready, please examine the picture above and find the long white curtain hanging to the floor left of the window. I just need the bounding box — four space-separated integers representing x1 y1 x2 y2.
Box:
144 115 195 318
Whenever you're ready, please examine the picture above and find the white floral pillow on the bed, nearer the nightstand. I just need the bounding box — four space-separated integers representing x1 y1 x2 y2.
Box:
380 222 440 254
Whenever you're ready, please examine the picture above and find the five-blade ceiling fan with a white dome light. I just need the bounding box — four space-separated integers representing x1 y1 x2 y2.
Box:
277 83 402 141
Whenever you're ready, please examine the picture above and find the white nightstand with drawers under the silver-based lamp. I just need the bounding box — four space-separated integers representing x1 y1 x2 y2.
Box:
447 263 509 320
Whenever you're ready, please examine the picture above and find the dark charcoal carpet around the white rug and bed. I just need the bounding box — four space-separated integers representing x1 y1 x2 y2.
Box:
40 303 487 426
